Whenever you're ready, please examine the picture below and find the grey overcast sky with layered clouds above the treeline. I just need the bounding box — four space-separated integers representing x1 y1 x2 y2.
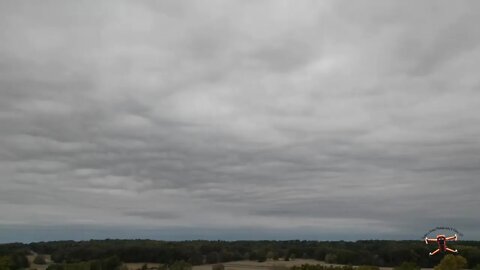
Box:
0 0 480 242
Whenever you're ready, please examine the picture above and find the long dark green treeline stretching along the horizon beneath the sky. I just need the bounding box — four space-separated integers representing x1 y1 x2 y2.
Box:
0 239 480 268
